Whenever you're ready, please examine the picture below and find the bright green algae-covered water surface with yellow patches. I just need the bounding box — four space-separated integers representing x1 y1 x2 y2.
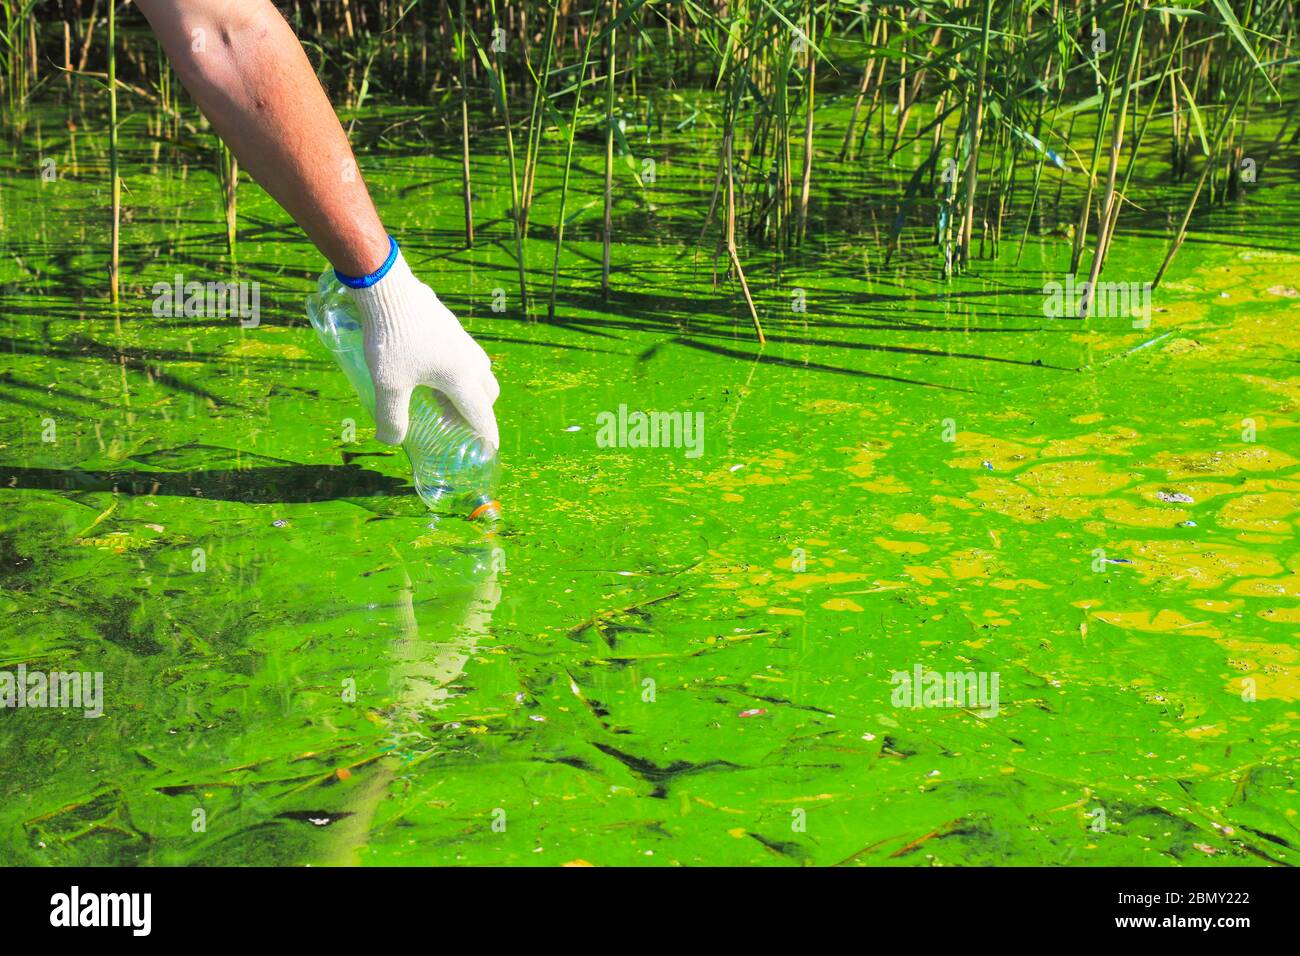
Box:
0 87 1300 866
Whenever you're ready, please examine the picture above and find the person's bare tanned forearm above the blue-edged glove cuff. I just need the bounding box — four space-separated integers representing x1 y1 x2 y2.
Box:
137 0 389 276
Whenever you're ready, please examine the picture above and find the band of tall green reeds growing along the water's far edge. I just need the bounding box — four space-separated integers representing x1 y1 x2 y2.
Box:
0 0 1297 338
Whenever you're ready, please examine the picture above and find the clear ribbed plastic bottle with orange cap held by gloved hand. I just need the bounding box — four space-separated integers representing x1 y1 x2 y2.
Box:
307 269 501 522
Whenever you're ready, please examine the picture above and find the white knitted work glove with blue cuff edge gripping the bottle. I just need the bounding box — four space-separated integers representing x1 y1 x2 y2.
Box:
347 251 501 449
